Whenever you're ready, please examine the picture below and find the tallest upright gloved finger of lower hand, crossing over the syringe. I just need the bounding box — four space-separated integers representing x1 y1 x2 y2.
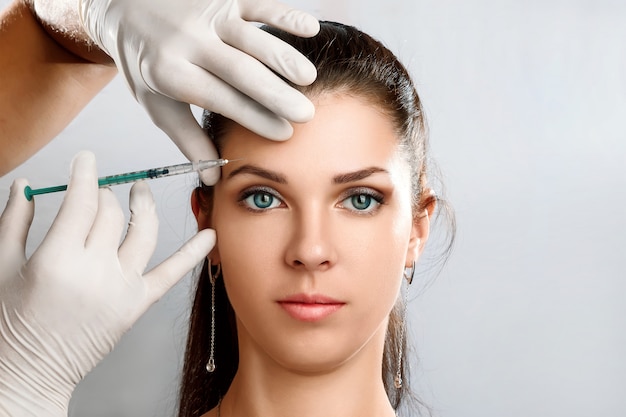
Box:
48 151 98 247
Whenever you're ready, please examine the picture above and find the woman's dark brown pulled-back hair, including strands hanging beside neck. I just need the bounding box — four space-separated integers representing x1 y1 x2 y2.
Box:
179 22 451 417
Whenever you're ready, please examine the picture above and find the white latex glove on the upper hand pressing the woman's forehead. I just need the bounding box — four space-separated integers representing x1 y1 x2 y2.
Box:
78 0 319 184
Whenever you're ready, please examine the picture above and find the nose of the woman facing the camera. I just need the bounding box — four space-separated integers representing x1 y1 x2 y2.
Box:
285 210 337 271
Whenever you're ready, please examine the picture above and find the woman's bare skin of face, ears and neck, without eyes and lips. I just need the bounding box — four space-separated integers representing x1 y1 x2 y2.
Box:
192 94 429 417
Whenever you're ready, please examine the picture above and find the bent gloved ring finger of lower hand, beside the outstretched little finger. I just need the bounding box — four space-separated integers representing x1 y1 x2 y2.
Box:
118 181 159 276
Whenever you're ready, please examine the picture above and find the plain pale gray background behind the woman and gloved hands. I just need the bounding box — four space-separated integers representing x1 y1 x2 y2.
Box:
0 0 626 417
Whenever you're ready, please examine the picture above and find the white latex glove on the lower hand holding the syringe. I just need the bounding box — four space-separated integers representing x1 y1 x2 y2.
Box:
0 152 215 417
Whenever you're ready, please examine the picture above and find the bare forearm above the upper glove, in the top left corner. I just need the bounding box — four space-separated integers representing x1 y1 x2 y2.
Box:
0 0 116 176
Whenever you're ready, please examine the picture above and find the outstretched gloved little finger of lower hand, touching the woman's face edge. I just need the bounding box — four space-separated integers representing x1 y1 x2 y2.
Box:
145 229 215 303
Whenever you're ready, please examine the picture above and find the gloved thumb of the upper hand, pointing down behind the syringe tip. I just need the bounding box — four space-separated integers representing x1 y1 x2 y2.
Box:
141 97 220 185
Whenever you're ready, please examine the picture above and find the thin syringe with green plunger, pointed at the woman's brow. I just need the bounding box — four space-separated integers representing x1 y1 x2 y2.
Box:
24 159 229 201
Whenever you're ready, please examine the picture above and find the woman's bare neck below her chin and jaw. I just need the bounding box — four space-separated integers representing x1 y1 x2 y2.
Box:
220 329 395 417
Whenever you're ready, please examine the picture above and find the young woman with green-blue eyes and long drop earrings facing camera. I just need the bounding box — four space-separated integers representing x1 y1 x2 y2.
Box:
179 22 450 417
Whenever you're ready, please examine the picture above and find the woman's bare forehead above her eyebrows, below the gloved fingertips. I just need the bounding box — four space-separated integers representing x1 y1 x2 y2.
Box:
221 94 398 175
